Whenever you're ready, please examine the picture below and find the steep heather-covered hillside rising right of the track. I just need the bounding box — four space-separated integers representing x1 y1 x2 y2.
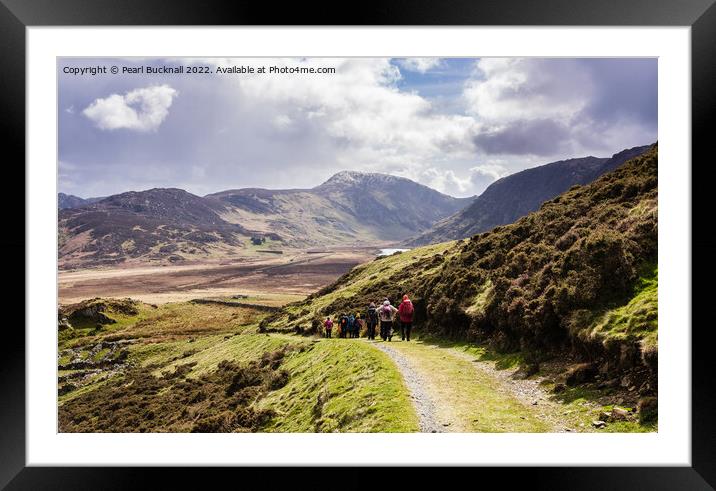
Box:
262 145 658 397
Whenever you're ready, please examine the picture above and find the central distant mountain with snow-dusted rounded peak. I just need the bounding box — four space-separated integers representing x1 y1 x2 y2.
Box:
207 171 470 247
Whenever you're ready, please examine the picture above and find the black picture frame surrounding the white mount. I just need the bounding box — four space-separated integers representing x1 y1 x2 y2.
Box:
0 0 716 489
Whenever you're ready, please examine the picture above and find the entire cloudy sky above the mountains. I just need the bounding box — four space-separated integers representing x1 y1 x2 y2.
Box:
58 58 657 198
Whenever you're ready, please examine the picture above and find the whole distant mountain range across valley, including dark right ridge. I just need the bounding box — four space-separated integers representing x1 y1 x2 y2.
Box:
58 146 650 268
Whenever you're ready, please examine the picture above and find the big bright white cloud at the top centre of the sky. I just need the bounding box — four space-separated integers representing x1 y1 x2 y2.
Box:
231 58 474 175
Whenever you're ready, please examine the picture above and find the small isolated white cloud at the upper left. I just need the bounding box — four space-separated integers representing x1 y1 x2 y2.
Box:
82 84 178 132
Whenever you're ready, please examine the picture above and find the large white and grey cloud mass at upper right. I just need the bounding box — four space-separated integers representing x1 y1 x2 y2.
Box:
463 58 657 156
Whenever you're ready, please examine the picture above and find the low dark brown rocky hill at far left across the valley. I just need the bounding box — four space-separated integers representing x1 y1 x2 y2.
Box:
59 189 250 267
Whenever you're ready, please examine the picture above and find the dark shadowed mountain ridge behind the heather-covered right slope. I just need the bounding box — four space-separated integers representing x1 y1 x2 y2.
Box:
406 145 650 246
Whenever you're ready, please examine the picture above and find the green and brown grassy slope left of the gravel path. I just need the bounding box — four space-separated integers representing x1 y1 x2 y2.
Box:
58 299 418 432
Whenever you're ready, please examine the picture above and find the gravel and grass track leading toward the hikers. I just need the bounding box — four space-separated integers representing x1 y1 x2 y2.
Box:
374 341 560 432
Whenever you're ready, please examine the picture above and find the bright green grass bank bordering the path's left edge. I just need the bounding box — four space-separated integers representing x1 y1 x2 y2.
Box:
260 339 419 432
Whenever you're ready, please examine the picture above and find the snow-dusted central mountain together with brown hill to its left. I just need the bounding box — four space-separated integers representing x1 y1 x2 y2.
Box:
59 172 469 268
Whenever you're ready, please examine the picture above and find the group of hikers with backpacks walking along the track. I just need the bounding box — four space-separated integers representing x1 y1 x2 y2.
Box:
323 295 415 341
